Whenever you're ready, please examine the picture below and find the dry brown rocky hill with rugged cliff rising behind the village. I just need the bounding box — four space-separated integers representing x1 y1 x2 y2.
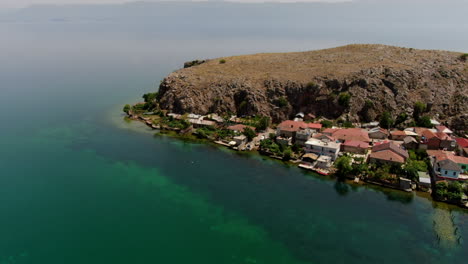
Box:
159 45 468 133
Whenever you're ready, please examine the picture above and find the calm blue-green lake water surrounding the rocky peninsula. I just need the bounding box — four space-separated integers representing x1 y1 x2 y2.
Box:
0 2 468 264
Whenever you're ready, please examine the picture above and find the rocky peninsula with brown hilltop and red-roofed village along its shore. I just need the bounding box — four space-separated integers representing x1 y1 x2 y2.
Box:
123 45 468 207
